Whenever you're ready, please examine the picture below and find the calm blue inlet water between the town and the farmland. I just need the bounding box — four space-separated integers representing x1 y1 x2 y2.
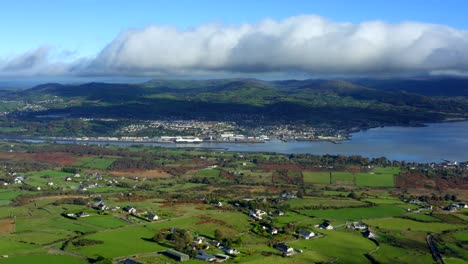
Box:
5 121 468 162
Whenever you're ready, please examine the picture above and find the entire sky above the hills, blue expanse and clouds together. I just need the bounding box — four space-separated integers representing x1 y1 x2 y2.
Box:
0 0 468 80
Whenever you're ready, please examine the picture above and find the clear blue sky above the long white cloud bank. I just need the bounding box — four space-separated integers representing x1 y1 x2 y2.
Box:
0 0 468 78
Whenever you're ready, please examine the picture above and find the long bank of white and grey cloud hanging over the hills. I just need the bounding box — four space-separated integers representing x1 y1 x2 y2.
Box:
0 16 468 76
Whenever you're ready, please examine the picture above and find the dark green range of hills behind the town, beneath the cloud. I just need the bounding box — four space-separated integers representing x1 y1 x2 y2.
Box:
5 79 468 129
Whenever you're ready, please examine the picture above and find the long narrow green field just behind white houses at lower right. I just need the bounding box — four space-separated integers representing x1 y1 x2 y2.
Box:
302 205 405 220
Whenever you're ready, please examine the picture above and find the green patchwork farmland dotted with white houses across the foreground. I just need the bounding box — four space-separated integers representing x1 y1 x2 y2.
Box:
0 144 468 264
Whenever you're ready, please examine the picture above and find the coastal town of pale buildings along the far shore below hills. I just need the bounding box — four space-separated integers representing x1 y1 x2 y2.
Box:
48 119 348 143
